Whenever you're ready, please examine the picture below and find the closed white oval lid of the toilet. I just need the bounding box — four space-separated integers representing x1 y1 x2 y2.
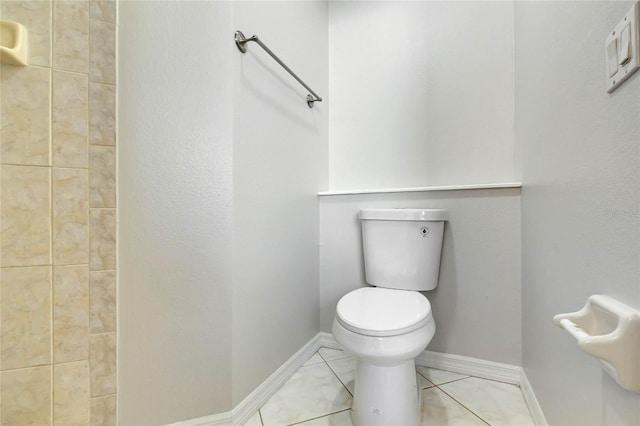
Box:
336 287 431 336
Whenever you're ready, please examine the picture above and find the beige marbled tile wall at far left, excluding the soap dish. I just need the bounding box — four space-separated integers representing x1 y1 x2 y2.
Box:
0 0 117 426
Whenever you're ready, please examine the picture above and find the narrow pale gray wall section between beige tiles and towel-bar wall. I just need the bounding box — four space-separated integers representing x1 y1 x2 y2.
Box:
118 1 236 425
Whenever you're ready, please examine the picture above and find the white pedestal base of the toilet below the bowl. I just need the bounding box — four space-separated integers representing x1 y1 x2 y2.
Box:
351 359 422 426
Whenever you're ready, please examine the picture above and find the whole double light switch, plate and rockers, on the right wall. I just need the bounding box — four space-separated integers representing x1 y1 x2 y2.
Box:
605 2 640 93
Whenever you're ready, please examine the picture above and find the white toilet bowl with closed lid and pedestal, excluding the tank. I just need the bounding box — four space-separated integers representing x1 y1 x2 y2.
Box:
332 287 436 426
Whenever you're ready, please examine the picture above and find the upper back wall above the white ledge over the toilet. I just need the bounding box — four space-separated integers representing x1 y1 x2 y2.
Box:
329 1 516 190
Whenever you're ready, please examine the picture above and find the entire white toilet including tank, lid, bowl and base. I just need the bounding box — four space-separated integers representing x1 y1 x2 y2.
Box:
332 209 447 426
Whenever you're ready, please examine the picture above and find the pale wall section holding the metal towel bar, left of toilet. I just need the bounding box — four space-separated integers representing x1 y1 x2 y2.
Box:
232 2 328 405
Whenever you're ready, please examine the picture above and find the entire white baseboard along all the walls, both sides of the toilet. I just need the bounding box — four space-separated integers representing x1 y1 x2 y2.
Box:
171 333 547 426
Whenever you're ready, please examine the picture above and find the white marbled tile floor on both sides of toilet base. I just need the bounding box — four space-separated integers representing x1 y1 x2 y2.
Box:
247 348 533 426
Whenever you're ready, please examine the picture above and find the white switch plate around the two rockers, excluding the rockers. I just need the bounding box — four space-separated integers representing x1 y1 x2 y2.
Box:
605 2 640 93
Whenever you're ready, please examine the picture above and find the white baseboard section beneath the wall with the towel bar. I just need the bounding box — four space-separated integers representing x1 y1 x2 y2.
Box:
232 333 328 425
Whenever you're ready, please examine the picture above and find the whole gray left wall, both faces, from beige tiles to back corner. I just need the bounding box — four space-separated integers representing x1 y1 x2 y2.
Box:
118 1 328 425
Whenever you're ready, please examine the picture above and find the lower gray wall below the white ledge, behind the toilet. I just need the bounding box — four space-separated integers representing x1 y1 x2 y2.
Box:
320 189 521 365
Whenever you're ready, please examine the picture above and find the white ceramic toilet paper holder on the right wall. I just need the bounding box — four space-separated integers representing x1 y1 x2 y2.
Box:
553 295 640 392
